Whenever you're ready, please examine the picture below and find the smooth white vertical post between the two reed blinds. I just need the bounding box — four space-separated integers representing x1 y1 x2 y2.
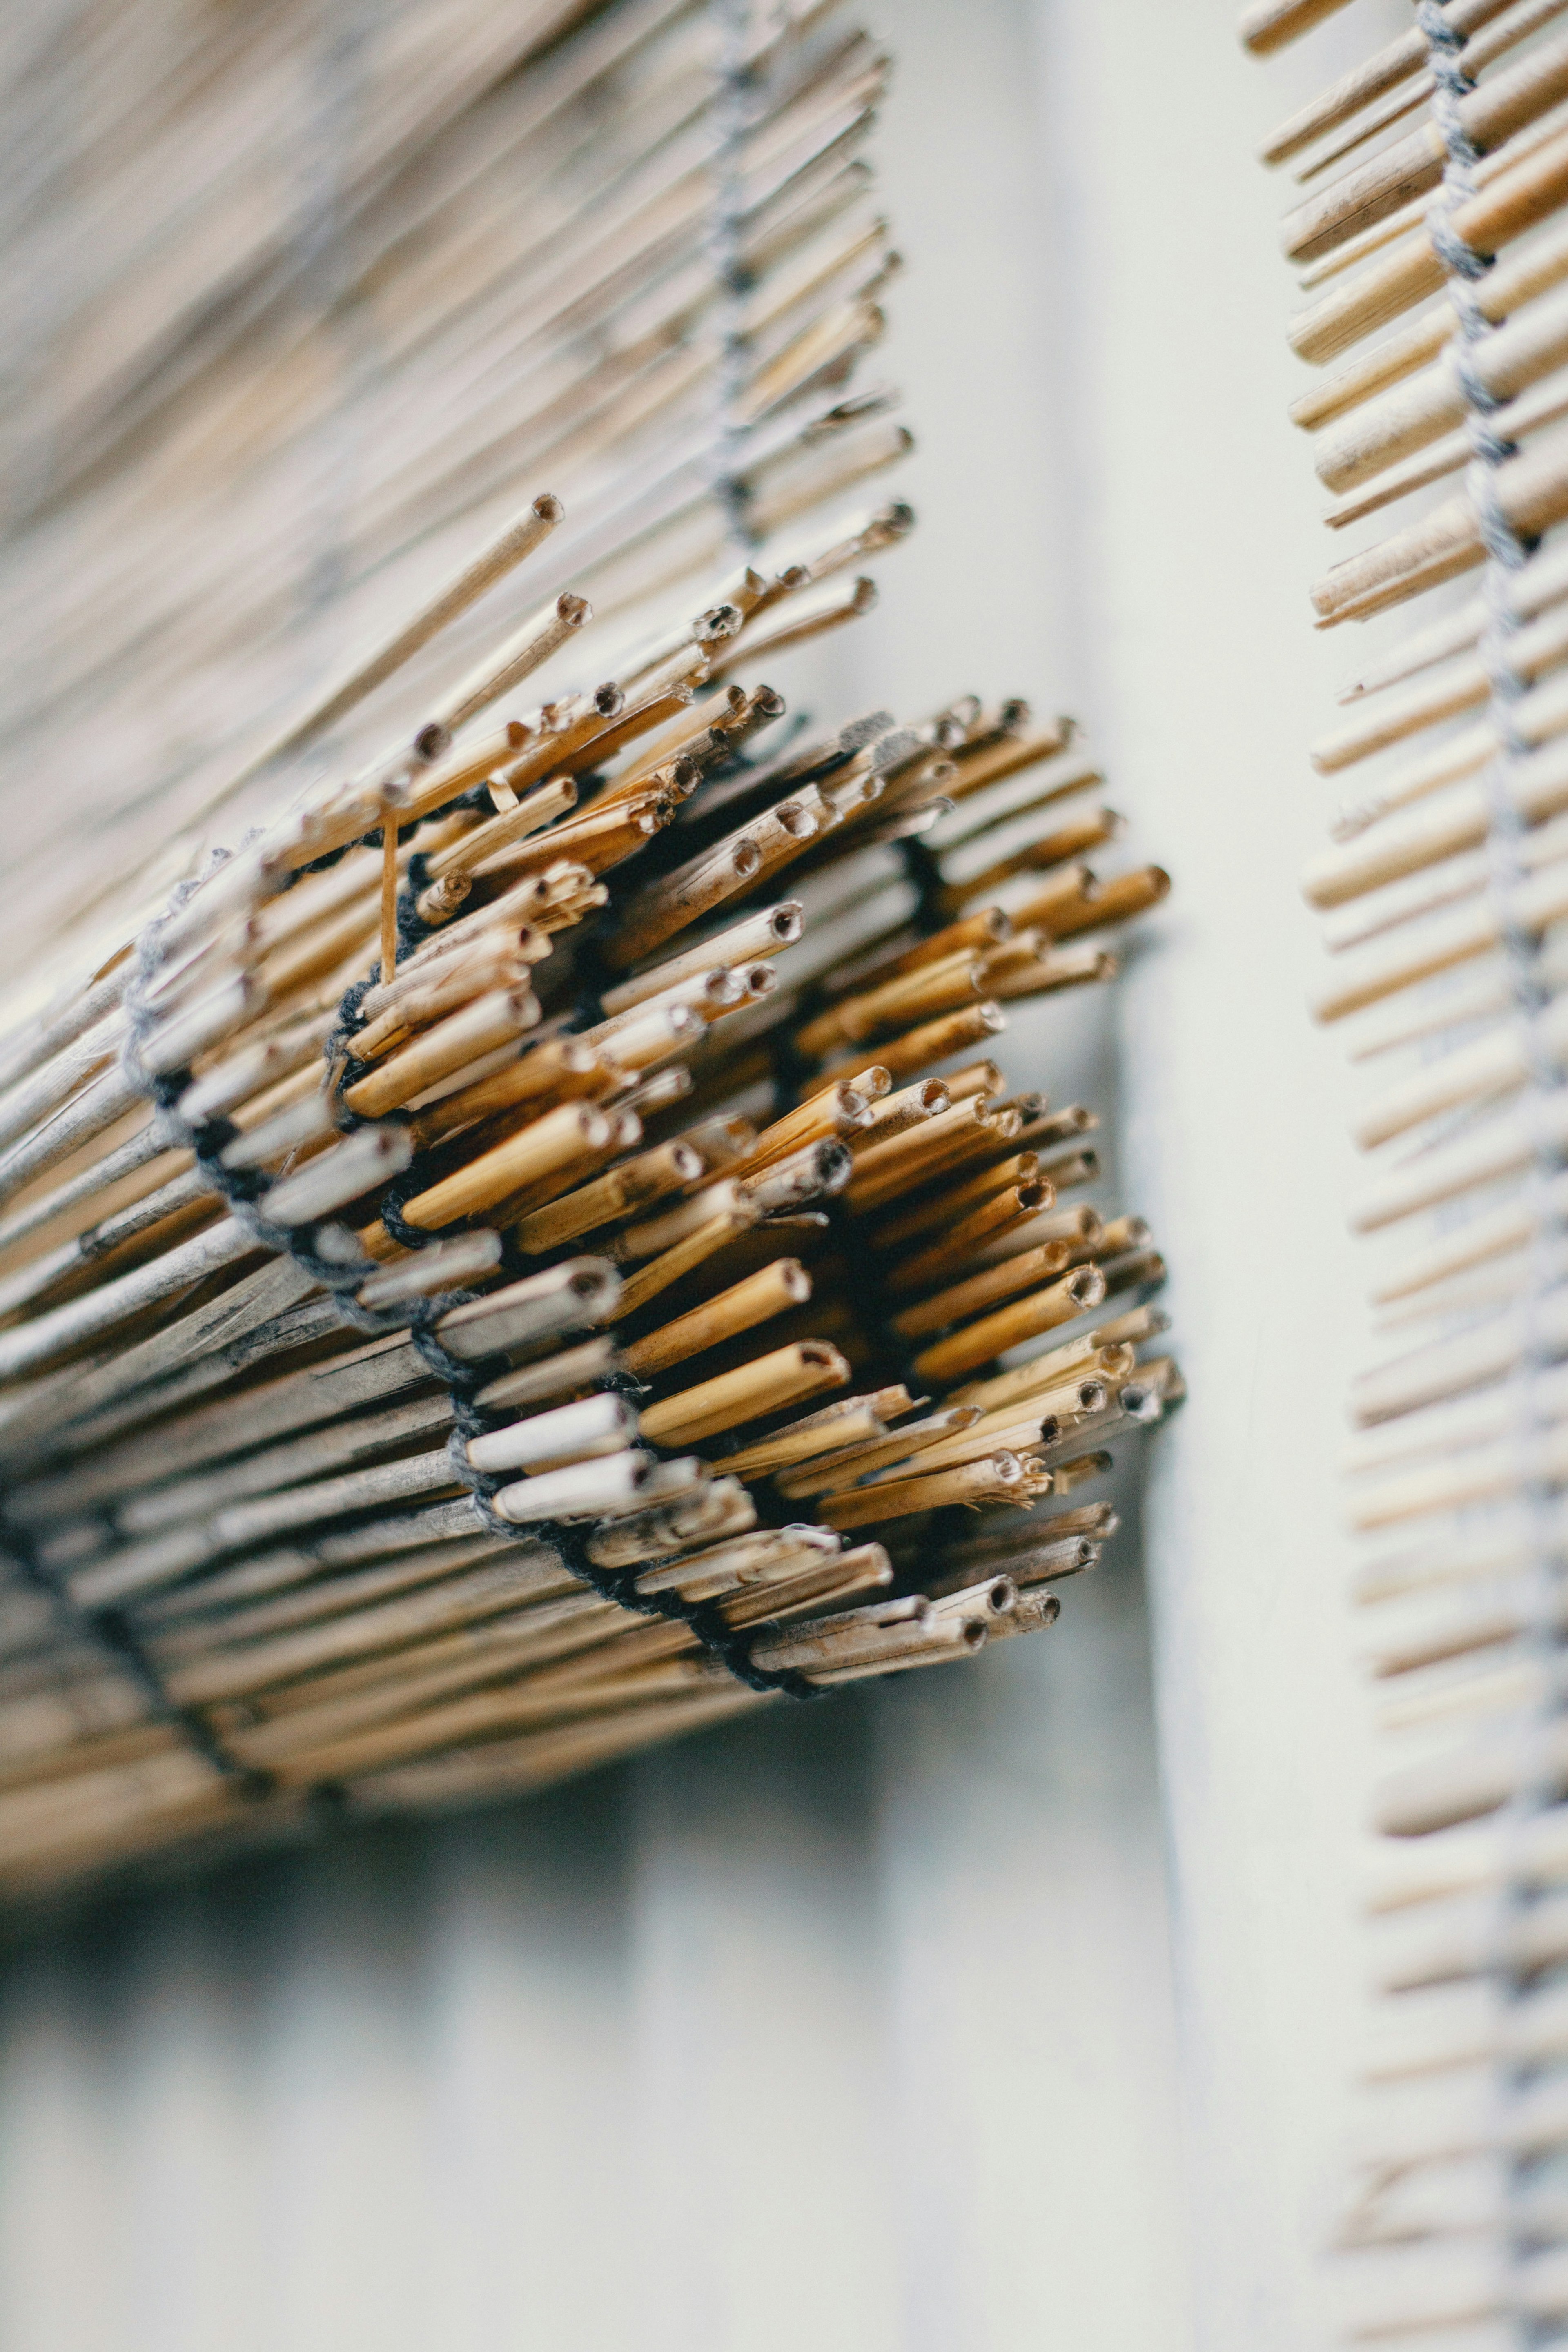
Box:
1037 0 1408 2352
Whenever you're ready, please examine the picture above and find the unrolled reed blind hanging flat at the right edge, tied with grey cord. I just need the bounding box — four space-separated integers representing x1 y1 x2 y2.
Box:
1244 0 1568 2352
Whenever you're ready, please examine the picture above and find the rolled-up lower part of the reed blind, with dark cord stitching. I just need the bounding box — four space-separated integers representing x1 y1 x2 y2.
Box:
0 541 1180 1886
